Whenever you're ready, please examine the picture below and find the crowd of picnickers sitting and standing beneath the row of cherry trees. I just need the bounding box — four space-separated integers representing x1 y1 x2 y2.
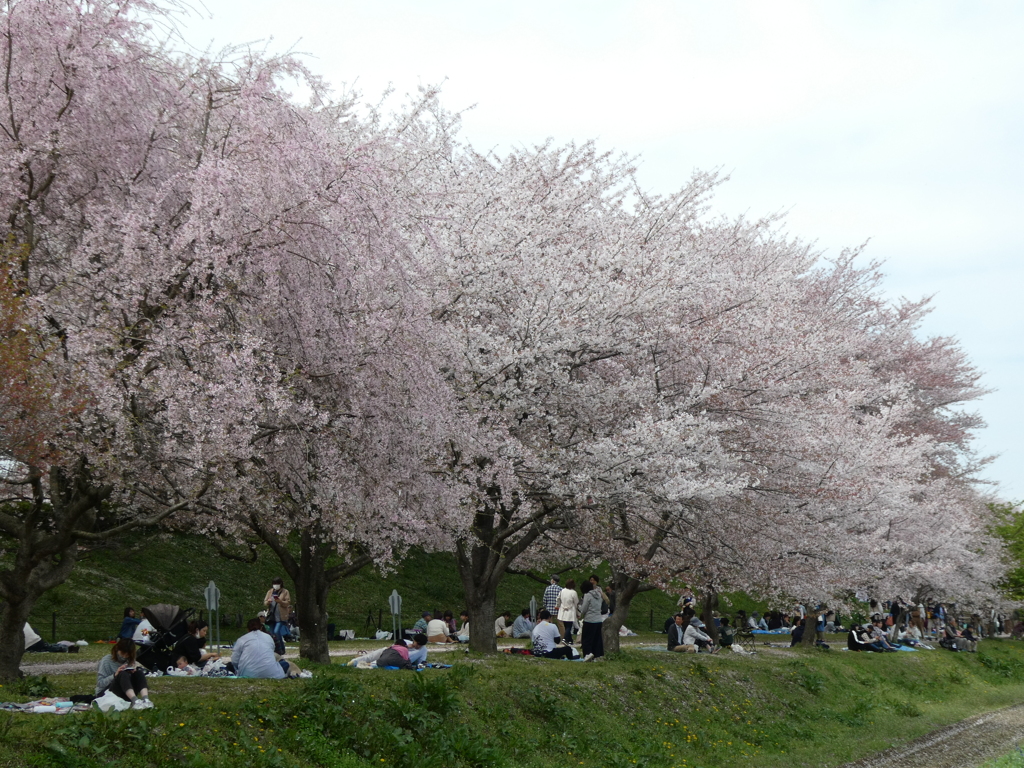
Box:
25 573 1024 709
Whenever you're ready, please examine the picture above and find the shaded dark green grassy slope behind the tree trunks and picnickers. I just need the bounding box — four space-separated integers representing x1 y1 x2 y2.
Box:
25 534 696 640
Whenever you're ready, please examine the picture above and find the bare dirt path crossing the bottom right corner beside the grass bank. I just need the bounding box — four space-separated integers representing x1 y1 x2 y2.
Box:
842 705 1024 768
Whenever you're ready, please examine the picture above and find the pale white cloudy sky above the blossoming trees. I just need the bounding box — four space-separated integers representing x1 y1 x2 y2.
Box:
181 0 1024 501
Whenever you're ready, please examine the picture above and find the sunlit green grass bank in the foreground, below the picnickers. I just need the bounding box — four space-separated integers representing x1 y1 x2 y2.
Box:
6 638 1024 768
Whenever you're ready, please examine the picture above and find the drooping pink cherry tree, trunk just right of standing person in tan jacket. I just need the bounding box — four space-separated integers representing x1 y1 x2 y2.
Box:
174 83 458 663
